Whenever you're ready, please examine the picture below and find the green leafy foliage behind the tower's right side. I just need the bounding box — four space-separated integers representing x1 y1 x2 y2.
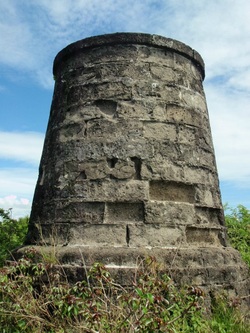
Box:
225 205 250 266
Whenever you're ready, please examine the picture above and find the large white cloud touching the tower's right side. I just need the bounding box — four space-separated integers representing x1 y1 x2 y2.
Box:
206 83 250 186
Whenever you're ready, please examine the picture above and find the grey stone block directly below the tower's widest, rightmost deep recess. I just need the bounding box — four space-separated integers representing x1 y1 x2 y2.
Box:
145 201 196 226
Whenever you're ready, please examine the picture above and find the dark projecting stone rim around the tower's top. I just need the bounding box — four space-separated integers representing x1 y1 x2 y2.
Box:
53 32 205 79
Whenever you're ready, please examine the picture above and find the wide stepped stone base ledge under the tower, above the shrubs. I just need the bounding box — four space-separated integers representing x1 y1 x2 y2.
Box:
13 246 250 308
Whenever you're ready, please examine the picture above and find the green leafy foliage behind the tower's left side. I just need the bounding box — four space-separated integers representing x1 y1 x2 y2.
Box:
0 208 29 266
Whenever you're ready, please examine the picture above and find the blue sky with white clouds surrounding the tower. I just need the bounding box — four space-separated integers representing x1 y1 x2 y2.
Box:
0 0 250 217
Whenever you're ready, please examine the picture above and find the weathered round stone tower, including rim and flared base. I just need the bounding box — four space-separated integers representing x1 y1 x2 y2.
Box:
24 33 247 293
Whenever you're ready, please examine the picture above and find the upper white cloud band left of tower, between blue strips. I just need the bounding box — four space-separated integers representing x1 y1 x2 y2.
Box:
0 131 44 165
